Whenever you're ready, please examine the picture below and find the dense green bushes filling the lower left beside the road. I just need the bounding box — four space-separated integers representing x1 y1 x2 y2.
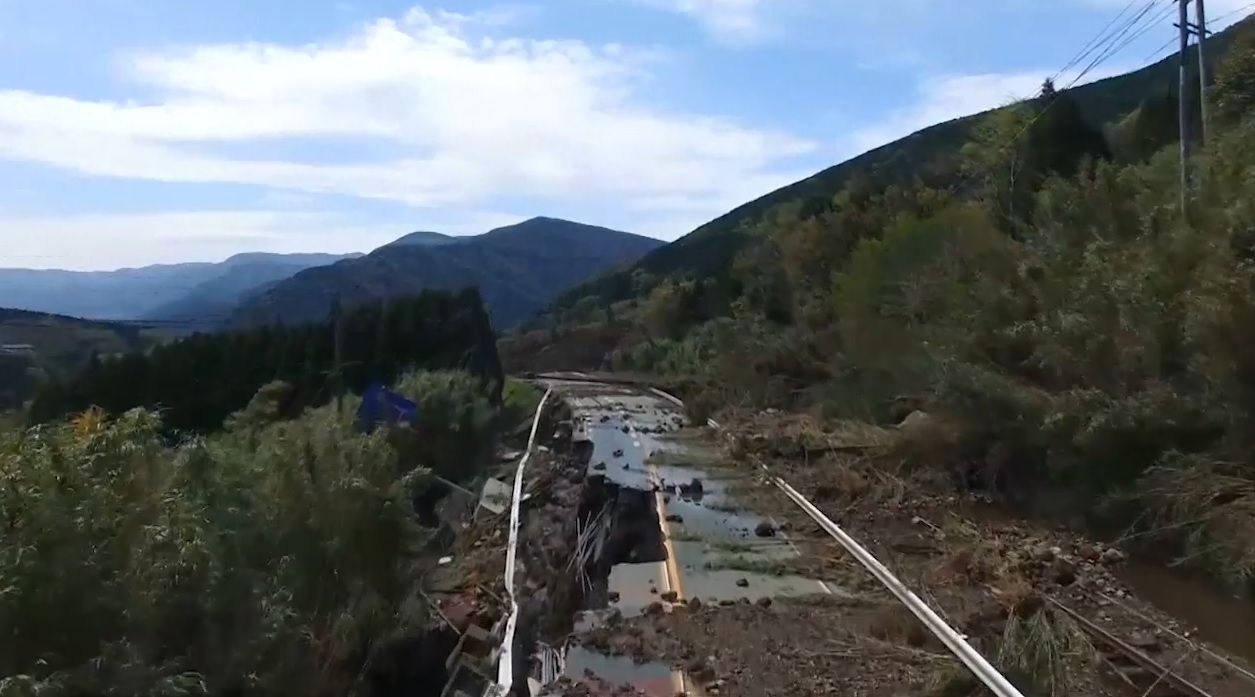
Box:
0 372 522 697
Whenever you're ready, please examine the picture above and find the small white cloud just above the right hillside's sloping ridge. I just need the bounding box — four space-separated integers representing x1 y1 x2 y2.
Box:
840 67 1128 157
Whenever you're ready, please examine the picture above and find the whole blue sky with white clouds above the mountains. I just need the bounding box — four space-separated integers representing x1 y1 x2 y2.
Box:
0 0 1255 270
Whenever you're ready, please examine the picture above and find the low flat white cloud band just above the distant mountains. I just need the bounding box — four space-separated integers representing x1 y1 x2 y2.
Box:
0 210 523 270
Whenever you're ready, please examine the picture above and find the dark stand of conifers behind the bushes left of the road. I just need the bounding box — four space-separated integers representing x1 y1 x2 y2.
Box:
30 289 503 431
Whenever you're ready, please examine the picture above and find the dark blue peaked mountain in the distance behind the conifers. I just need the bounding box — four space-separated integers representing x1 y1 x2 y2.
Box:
231 217 663 327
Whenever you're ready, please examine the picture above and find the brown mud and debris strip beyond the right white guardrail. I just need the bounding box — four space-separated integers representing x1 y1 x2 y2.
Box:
712 414 1255 697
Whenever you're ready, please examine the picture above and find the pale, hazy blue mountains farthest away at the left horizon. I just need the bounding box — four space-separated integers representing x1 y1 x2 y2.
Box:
0 252 355 320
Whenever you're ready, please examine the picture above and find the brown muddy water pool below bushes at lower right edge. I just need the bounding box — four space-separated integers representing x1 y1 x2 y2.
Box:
1118 561 1255 666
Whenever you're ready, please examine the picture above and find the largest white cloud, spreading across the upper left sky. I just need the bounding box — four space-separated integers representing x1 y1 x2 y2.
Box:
0 9 813 221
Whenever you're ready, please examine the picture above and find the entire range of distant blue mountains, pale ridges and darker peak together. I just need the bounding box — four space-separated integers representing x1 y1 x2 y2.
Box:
0 217 663 332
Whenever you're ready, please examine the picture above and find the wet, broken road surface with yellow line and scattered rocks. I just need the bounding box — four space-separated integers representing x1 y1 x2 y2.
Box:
539 383 842 694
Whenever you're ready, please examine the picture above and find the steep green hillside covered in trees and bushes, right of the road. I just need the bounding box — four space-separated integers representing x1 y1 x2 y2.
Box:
501 21 1255 590
